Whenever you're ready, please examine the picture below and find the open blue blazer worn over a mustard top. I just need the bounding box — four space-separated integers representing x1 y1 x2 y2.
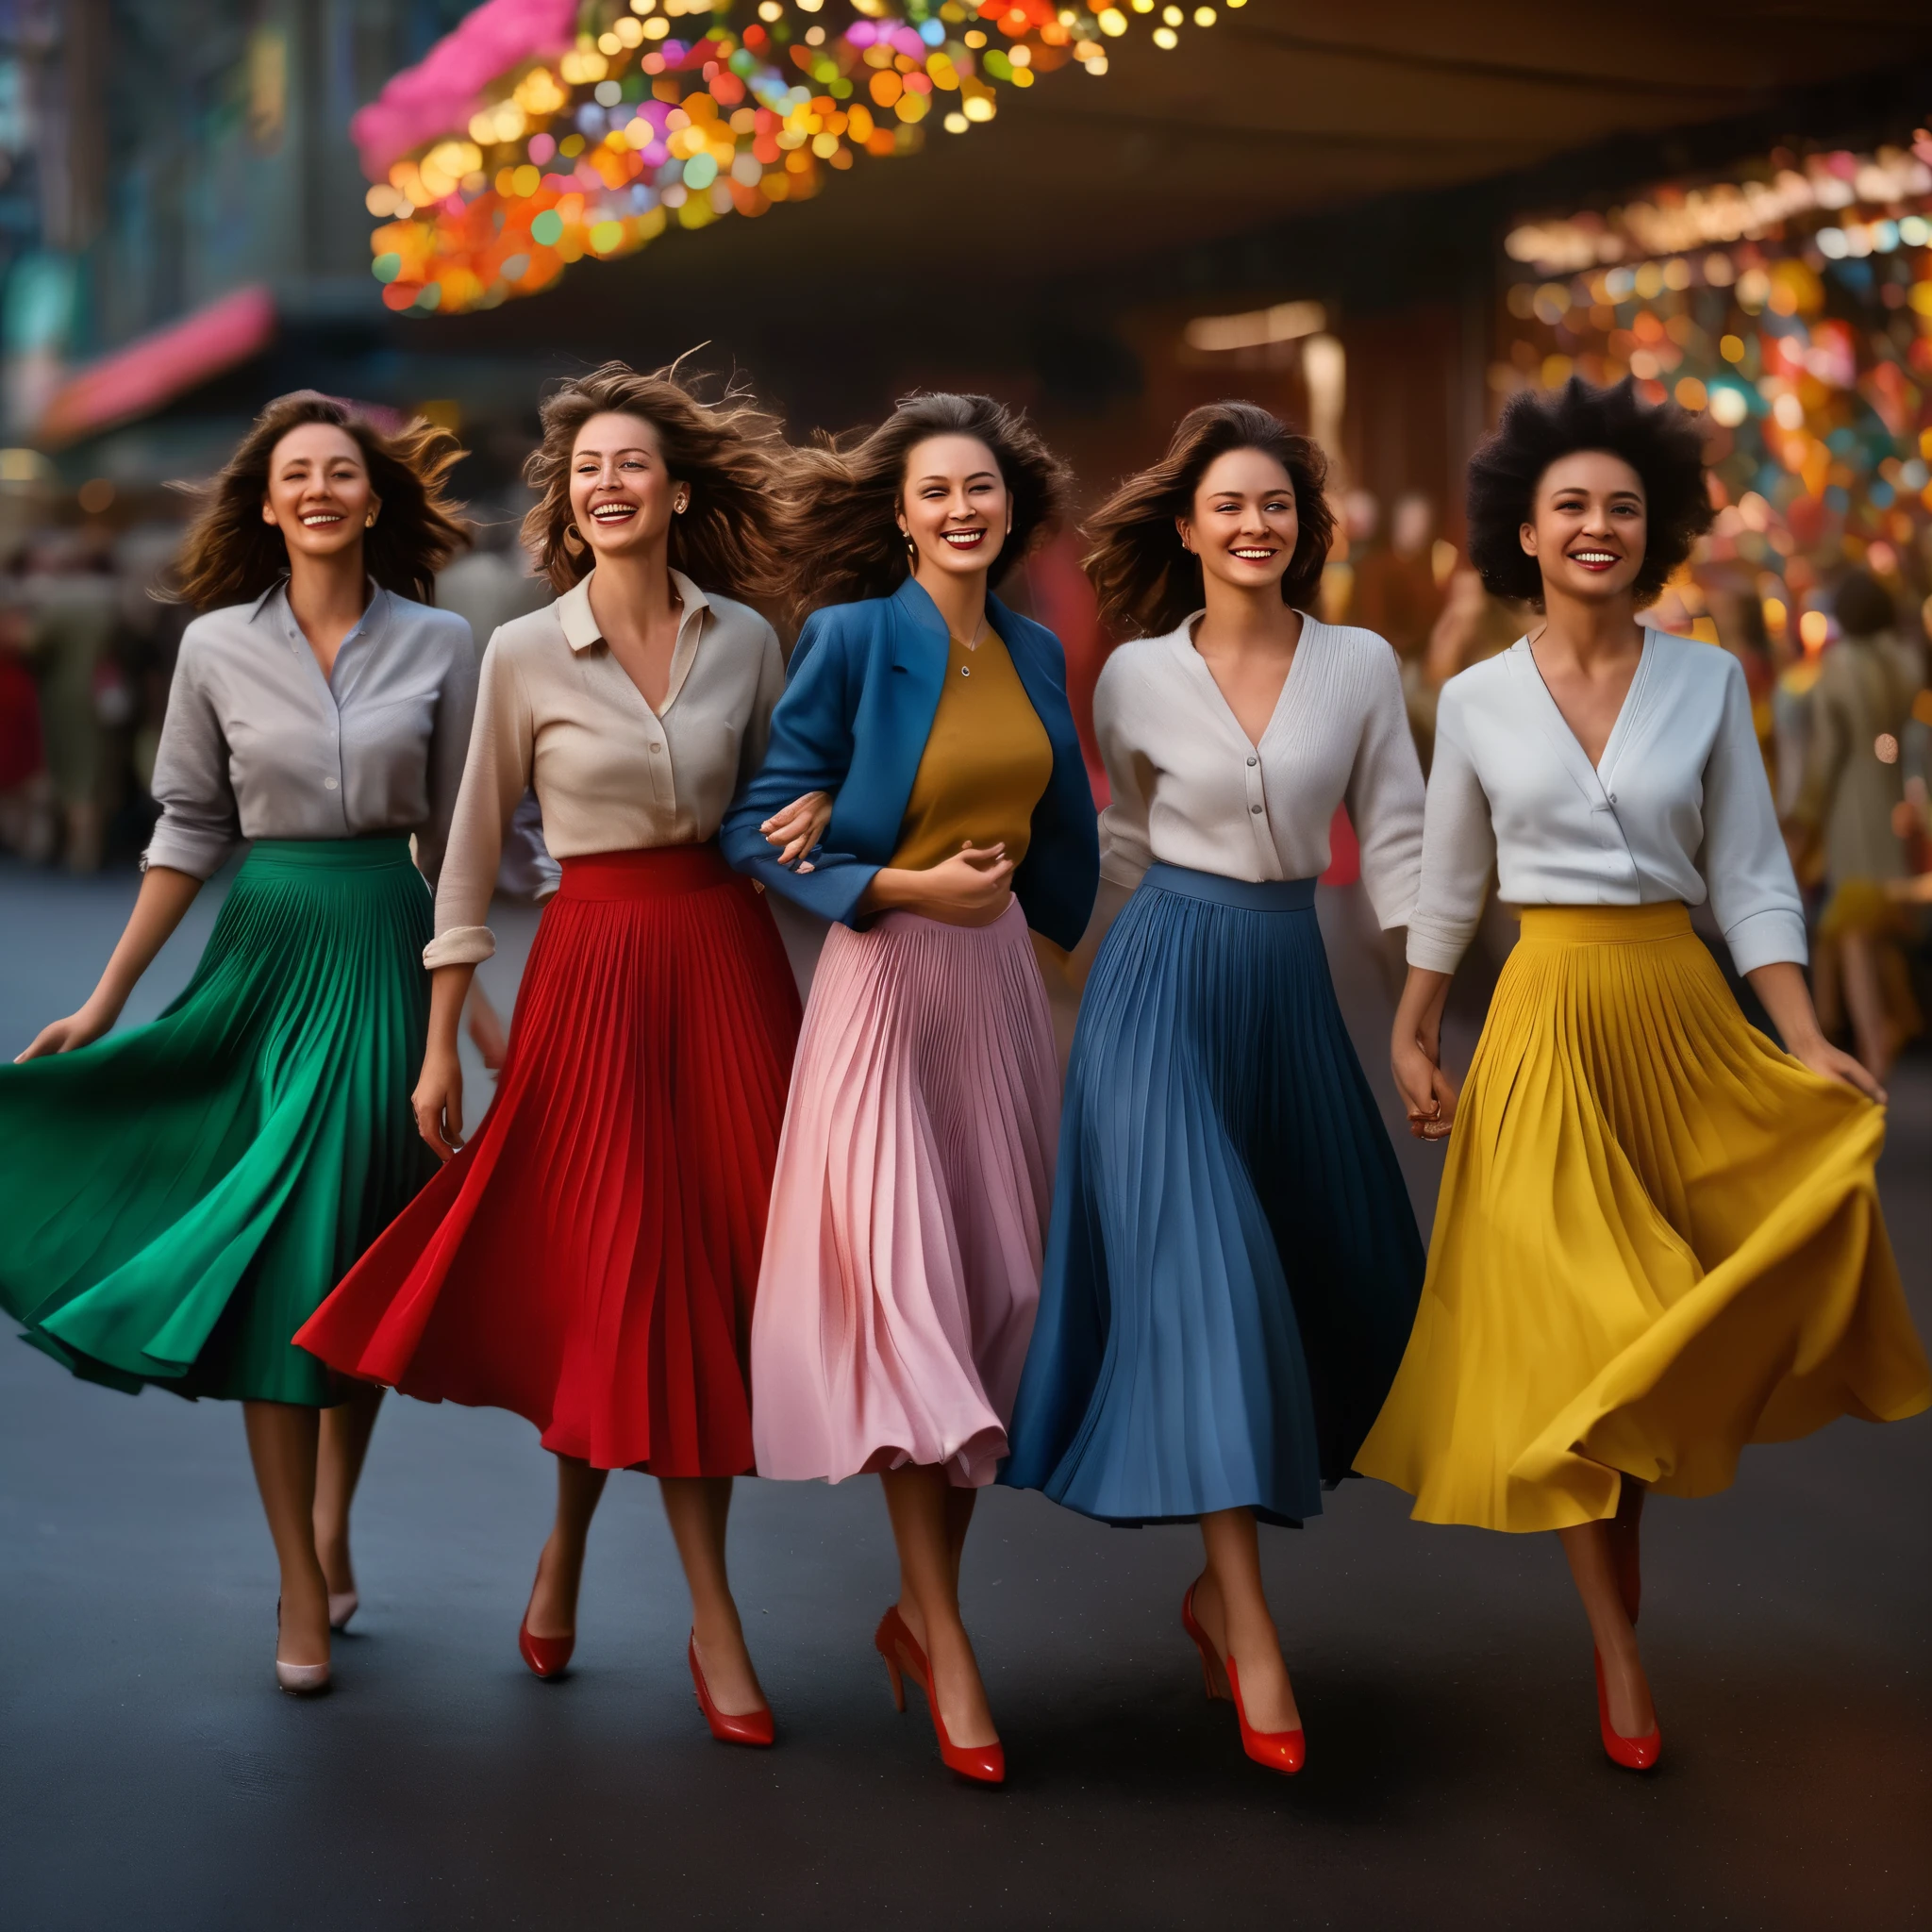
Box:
719 577 1099 949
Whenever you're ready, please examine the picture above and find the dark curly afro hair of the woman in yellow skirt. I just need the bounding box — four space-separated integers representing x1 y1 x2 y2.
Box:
1468 375 1714 610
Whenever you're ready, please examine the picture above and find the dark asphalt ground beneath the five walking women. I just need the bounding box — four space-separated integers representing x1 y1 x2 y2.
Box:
0 868 1932 1932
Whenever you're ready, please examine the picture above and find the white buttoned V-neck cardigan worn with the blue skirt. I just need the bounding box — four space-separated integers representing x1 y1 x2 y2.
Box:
1093 612 1422 927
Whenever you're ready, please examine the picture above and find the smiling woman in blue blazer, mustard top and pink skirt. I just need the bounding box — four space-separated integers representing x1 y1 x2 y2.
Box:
724 396 1097 1783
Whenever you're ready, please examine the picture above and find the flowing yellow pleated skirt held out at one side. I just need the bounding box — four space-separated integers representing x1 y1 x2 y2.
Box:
1355 904 1932 1530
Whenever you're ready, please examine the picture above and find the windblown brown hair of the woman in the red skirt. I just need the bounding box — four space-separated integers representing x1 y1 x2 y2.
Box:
524 361 784 599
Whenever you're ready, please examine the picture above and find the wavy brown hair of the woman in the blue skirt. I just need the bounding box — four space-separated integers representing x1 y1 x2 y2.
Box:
1082 402 1335 638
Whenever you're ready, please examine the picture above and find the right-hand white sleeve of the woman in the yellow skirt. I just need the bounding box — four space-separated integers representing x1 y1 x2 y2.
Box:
1698 658 1807 974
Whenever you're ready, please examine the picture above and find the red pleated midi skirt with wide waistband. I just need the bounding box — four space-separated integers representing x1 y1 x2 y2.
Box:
295 844 798 1476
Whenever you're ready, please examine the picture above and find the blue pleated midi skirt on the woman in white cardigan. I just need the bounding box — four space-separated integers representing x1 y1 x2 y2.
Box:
1001 866 1424 1524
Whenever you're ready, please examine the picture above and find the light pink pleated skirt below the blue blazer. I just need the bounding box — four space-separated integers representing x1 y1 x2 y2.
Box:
752 902 1060 1488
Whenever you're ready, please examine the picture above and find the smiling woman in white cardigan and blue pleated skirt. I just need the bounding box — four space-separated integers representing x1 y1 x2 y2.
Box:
1003 402 1422 1772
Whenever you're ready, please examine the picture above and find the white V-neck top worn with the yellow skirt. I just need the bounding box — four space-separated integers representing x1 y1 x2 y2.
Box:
1408 630 1805 972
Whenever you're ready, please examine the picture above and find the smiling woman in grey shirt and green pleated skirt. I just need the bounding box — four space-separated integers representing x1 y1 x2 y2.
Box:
0 392 475 1690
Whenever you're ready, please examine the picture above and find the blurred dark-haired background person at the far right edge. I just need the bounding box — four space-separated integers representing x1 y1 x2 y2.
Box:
1787 570 1924 1080
